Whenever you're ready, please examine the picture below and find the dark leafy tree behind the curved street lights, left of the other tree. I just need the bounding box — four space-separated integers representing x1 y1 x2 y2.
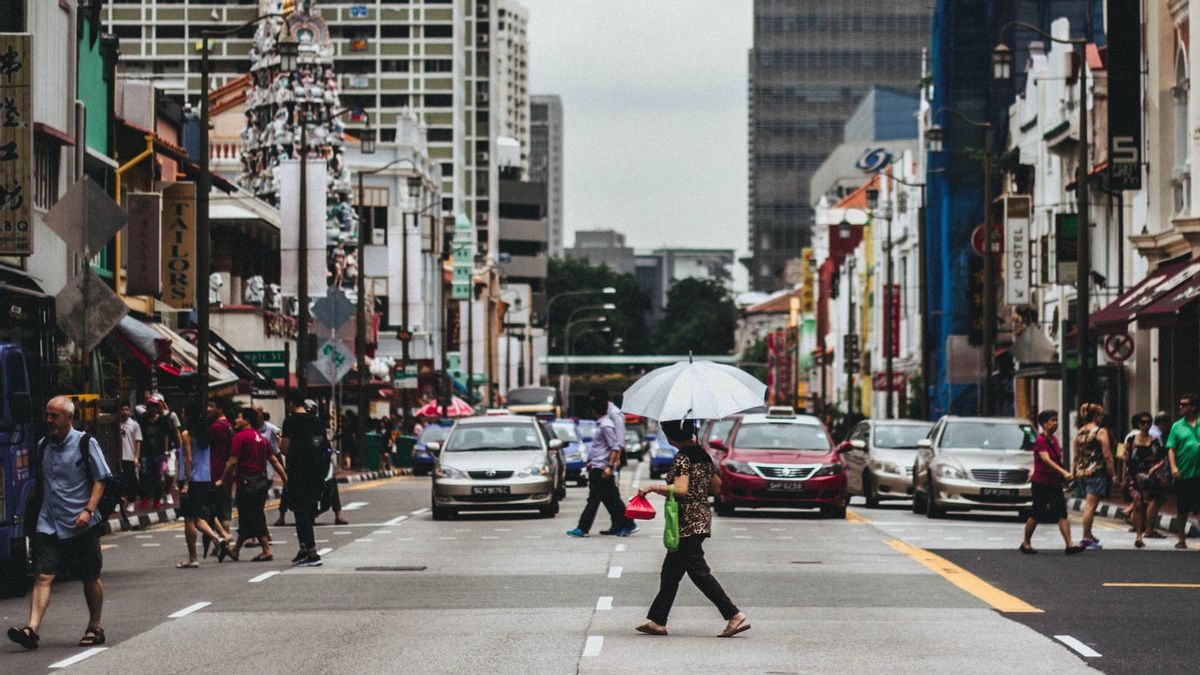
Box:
546 253 654 354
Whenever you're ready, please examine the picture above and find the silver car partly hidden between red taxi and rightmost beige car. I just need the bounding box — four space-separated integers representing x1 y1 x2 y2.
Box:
839 419 934 508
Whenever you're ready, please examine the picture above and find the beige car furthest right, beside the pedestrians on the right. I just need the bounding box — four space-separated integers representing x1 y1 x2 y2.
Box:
912 417 1037 518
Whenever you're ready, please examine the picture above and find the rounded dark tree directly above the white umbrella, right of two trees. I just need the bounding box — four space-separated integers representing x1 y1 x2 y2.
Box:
658 279 738 354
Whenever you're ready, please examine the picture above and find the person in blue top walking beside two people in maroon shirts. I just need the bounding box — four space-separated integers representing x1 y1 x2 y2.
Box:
175 407 229 569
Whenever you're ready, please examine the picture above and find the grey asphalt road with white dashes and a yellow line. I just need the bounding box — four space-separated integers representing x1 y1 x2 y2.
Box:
0 458 1200 674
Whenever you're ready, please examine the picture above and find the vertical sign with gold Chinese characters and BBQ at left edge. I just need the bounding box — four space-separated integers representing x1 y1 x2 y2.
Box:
0 32 34 256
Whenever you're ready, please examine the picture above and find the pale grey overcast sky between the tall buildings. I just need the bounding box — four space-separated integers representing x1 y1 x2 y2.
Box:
520 0 754 288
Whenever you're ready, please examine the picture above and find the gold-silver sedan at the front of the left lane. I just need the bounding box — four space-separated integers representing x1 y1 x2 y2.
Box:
430 416 566 520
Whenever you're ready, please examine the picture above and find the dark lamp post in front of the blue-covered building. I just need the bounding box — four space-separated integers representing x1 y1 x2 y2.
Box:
925 108 996 416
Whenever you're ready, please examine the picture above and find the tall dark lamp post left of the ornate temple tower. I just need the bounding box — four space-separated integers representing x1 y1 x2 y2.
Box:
196 13 300 410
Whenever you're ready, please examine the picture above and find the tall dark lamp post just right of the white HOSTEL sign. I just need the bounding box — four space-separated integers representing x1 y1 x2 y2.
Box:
991 22 1094 408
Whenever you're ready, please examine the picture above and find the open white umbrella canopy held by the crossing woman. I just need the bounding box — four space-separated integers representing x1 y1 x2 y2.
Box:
620 358 767 420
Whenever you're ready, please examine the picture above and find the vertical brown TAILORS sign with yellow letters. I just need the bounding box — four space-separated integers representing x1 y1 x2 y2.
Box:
162 183 196 310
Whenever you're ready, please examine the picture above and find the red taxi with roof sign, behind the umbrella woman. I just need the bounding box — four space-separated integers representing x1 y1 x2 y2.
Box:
708 411 848 518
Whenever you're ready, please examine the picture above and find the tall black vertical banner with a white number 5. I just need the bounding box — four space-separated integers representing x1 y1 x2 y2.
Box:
1104 0 1141 190
